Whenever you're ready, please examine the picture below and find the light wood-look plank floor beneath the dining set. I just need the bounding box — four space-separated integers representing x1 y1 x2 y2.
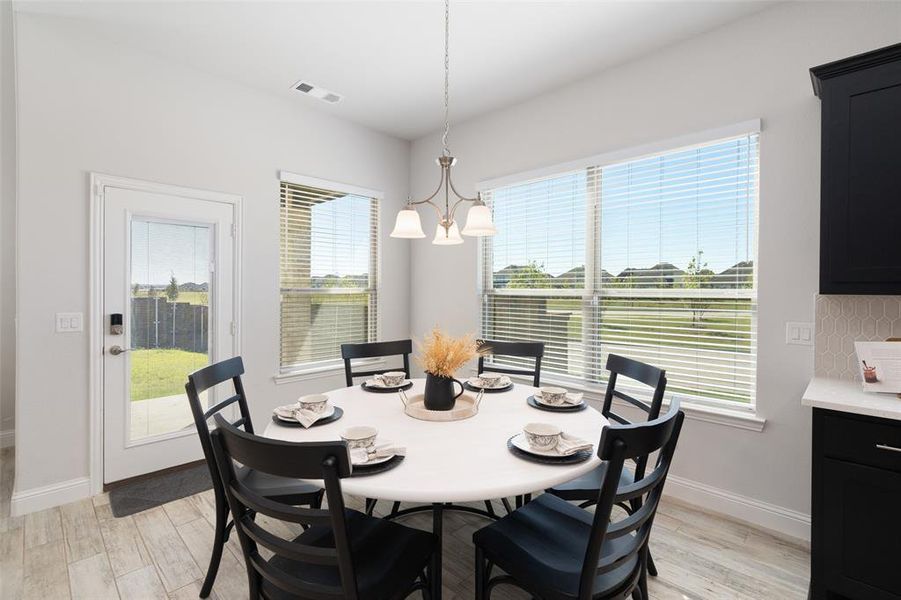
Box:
0 448 808 600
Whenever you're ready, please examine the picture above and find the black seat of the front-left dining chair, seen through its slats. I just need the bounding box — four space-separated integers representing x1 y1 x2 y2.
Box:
263 510 437 600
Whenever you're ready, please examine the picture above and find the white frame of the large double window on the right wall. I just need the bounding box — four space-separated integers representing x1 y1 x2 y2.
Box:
477 119 765 420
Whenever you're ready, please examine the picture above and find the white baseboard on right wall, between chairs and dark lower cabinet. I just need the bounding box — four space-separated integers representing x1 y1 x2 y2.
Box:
664 475 810 542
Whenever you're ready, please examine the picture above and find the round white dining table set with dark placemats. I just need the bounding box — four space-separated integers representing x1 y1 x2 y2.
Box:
263 379 607 590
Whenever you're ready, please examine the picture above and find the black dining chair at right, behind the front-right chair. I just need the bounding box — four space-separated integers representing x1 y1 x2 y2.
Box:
546 354 666 576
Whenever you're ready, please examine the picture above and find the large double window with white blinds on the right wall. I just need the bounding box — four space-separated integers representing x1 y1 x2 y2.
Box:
481 133 758 404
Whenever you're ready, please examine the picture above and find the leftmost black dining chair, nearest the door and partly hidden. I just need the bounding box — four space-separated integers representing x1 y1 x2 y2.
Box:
185 356 322 598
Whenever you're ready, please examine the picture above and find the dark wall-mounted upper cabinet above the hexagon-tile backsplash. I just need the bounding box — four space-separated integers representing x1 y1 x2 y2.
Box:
810 44 901 294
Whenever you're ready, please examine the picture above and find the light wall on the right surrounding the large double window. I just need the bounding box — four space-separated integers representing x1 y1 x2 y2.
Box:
411 3 901 536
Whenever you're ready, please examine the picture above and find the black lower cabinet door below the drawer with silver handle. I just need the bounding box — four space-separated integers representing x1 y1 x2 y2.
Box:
820 459 901 600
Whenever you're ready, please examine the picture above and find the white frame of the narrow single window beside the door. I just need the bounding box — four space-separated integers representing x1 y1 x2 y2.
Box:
274 171 385 384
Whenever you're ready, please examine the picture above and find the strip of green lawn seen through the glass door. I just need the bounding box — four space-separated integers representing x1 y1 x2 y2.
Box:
131 349 209 402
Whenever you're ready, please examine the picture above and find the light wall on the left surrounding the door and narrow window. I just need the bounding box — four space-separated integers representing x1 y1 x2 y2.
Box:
14 14 409 505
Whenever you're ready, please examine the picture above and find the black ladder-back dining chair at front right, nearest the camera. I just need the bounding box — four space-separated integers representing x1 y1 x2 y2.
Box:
472 405 684 600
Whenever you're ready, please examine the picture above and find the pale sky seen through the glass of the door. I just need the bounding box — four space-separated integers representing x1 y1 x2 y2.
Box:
131 220 210 286
